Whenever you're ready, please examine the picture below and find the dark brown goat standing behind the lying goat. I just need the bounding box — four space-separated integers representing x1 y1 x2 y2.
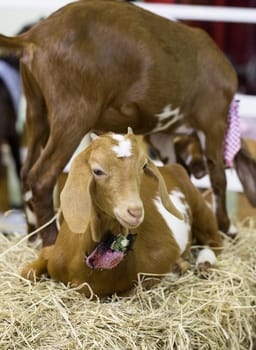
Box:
0 0 253 245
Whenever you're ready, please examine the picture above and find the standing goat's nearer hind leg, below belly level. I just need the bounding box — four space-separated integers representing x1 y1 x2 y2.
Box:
27 127 87 246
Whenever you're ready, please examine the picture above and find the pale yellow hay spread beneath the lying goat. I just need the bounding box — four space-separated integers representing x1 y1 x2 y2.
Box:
0 219 256 350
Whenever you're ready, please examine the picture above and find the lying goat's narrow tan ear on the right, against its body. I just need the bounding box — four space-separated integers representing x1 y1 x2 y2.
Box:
146 158 184 220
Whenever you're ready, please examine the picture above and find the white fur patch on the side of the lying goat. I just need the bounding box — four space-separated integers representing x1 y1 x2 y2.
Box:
154 190 190 253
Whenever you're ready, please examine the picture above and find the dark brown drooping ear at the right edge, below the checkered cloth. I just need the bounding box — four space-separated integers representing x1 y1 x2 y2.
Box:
234 140 256 207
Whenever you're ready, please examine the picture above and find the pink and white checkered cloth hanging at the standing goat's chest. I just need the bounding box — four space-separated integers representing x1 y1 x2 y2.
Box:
224 100 241 168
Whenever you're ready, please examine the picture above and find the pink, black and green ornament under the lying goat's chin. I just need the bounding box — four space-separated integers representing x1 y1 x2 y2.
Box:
85 232 134 270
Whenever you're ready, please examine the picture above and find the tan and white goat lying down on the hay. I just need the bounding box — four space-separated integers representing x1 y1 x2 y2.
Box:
22 133 222 296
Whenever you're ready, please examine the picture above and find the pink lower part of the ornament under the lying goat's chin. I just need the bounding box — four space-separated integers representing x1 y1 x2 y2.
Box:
86 243 124 270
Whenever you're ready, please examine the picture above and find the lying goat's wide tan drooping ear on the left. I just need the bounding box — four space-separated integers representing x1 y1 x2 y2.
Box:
60 152 92 233
